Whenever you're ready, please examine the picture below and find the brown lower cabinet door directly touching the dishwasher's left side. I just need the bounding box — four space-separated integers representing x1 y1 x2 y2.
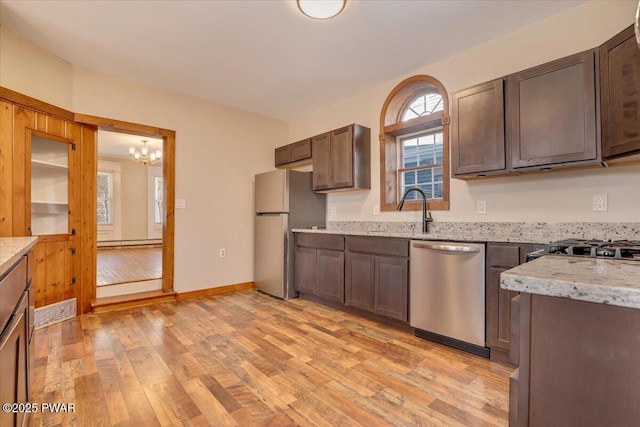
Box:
373 256 409 322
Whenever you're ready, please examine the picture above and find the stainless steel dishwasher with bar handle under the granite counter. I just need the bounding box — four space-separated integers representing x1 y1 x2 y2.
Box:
409 240 489 357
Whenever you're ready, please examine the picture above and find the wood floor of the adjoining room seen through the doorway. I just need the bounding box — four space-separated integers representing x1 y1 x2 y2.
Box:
97 248 162 286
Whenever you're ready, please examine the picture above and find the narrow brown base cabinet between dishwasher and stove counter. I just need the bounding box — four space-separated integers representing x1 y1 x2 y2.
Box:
485 243 534 364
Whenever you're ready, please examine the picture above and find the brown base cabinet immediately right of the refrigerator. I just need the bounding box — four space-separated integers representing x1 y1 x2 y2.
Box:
295 233 344 304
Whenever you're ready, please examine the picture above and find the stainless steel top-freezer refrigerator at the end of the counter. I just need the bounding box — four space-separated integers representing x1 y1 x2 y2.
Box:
253 169 326 299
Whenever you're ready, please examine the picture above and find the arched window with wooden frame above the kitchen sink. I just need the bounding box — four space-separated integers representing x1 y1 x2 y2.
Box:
380 76 449 211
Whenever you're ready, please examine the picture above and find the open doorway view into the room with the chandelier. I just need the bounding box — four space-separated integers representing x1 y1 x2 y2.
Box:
96 129 164 298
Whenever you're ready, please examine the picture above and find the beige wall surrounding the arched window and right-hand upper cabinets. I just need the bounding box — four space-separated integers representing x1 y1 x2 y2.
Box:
289 0 640 222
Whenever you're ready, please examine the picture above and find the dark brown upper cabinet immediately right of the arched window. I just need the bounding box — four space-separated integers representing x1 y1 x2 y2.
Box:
451 79 508 178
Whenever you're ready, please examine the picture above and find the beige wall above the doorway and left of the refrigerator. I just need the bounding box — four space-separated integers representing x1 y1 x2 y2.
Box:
0 29 288 292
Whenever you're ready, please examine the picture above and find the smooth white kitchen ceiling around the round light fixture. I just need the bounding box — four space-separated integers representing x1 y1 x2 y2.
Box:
0 0 584 121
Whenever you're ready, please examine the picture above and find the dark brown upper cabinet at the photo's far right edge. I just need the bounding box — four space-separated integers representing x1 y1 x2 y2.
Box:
600 25 640 159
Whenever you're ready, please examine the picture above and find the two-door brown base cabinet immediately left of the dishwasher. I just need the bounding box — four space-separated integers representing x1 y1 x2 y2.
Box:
345 236 409 322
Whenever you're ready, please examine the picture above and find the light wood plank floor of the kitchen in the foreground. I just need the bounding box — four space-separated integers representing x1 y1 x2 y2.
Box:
33 290 511 427
